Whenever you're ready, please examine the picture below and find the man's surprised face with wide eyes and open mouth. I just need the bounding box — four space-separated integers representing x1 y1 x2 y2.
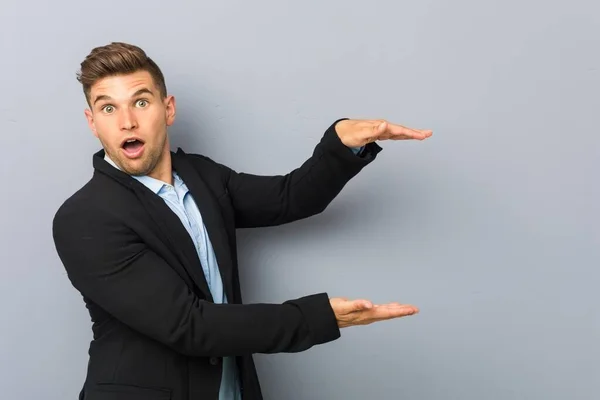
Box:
85 71 175 175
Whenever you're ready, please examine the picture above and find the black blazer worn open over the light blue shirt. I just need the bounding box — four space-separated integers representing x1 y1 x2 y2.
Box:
53 121 381 400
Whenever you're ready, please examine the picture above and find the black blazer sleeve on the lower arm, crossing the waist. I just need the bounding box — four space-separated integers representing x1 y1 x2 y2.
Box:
53 204 340 357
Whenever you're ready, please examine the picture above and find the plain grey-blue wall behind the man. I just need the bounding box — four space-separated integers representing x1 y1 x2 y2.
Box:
0 0 600 400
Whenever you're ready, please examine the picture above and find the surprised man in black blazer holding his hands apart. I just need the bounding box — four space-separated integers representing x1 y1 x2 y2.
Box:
53 43 431 400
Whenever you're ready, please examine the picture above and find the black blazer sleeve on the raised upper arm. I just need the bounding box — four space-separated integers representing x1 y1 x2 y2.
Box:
199 118 382 228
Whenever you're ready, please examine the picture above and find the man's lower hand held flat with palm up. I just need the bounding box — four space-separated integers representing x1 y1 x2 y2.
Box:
329 297 419 328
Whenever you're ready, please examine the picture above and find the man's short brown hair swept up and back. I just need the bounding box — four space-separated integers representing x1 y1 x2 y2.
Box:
77 42 167 103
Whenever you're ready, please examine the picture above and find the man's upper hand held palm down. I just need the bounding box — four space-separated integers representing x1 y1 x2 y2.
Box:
335 119 432 147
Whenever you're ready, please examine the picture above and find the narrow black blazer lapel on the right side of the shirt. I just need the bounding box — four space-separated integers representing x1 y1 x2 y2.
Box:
171 149 234 302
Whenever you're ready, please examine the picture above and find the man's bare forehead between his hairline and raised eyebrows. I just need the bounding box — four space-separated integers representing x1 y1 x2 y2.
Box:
90 71 156 100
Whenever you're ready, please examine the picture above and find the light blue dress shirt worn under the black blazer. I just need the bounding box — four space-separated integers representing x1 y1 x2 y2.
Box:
104 147 364 400
